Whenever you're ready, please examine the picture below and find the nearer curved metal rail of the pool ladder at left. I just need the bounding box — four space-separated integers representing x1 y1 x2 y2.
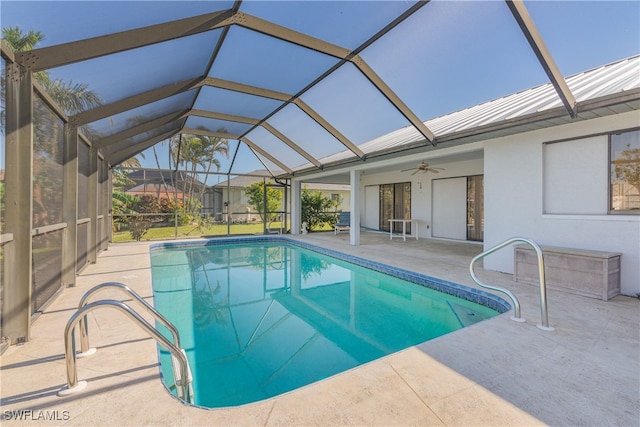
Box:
58 300 191 403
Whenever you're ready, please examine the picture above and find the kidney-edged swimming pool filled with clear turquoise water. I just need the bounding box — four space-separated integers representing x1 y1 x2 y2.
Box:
151 236 510 408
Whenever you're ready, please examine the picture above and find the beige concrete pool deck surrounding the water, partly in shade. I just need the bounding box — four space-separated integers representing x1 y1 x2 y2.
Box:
0 233 640 426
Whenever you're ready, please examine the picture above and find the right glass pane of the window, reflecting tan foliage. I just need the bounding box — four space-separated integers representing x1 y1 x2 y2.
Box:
610 130 640 214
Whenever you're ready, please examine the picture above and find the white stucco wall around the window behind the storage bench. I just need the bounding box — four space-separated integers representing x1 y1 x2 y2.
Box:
484 112 640 296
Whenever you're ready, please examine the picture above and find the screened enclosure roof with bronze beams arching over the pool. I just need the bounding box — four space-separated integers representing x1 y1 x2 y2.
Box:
0 0 640 174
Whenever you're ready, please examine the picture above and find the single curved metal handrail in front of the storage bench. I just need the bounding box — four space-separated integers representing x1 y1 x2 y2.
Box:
469 237 554 331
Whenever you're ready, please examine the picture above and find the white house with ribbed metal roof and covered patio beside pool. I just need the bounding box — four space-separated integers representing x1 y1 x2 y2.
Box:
292 57 640 296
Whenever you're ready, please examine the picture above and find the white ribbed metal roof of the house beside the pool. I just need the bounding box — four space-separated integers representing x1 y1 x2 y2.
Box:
306 56 640 171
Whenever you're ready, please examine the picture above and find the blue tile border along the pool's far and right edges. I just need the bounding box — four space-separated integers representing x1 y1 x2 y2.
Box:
149 236 511 313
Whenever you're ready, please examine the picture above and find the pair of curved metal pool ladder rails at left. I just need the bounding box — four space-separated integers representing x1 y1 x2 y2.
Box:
58 282 193 403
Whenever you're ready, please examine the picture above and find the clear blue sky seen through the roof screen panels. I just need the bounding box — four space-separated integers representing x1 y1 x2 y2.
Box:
0 0 640 172
